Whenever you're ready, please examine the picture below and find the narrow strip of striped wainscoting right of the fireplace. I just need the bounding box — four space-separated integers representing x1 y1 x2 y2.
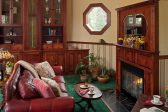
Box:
159 56 168 96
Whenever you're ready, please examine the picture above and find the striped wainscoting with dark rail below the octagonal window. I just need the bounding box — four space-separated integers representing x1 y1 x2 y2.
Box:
68 41 116 69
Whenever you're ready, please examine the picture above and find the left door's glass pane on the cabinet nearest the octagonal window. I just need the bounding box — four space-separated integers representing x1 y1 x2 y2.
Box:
44 0 52 24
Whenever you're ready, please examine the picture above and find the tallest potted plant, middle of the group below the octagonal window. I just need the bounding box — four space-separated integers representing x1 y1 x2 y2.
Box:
86 53 100 79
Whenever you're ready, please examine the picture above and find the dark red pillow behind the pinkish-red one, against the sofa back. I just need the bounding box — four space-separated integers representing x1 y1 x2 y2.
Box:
19 70 40 98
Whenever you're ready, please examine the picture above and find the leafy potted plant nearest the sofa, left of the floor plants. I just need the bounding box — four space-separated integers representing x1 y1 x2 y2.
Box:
75 61 88 82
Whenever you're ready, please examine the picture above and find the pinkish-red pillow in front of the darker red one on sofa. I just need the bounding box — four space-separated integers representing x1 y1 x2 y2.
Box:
33 78 55 98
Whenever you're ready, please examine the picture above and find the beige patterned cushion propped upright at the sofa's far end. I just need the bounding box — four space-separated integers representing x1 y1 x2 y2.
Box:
35 61 55 78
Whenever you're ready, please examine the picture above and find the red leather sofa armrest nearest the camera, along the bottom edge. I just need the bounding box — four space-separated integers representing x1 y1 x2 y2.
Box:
4 96 75 112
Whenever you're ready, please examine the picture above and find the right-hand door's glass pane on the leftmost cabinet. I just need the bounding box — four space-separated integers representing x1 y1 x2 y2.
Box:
13 0 21 24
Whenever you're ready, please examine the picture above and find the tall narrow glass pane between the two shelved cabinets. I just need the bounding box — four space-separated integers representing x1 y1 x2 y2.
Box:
28 0 36 48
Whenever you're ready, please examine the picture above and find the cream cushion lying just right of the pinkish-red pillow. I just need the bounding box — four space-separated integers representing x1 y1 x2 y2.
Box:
41 77 62 96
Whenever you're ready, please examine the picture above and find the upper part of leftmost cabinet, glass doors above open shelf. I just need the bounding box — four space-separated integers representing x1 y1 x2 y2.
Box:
0 0 23 44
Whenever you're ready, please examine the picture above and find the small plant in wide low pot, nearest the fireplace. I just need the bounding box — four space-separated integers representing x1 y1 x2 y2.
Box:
97 67 110 83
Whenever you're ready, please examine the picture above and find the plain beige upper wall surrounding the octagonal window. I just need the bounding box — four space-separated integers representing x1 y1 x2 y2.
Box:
67 0 145 43
